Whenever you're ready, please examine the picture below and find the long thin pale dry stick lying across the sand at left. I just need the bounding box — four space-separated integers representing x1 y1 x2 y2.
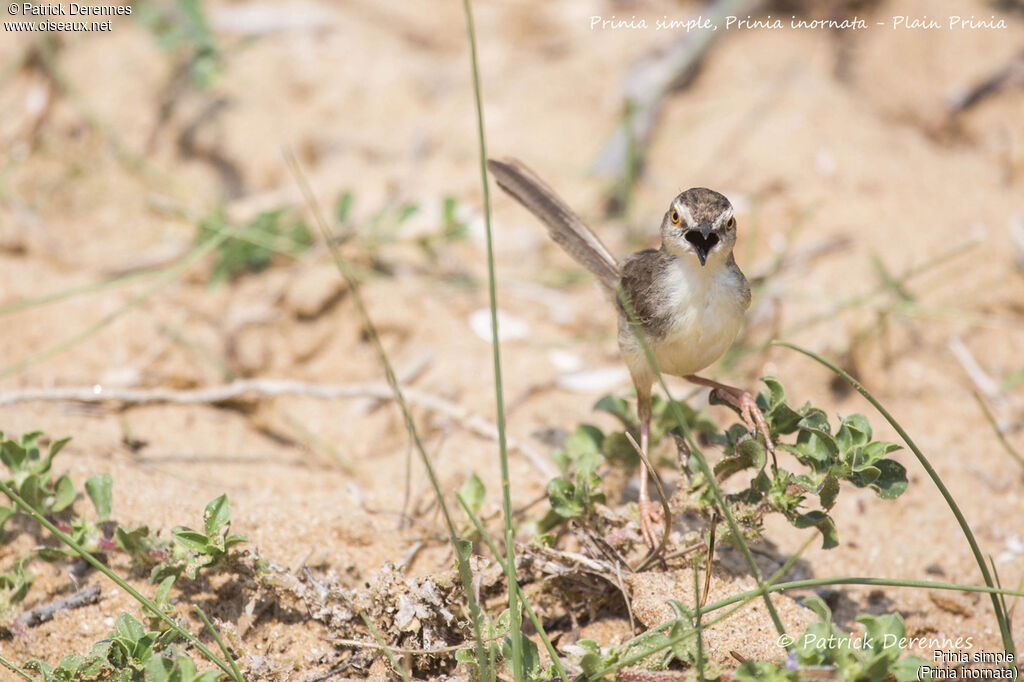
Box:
0 379 555 477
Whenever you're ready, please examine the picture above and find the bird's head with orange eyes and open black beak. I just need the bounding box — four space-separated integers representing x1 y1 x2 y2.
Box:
662 187 736 267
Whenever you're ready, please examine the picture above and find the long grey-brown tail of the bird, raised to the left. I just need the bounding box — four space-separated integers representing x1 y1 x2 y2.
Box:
487 159 620 292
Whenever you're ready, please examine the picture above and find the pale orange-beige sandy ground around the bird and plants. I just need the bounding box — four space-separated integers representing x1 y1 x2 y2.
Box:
0 0 1024 680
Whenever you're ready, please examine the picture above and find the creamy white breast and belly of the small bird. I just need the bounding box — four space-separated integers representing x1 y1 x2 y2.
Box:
652 259 746 376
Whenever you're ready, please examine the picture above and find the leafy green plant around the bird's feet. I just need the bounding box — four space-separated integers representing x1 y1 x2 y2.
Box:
538 377 907 549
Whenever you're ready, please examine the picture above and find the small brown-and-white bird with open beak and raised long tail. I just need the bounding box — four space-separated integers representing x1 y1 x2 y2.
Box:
487 160 774 547
